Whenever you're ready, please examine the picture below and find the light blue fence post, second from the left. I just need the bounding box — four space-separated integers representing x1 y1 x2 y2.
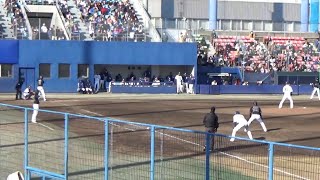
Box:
64 113 69 180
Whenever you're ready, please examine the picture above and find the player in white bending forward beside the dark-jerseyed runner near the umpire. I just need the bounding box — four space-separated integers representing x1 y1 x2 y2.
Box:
230 111 253 142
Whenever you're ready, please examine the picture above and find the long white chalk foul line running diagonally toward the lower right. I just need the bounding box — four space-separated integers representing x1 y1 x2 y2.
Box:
75 109 310 180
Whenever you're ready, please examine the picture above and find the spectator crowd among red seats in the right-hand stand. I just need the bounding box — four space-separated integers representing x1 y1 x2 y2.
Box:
198 31 320 73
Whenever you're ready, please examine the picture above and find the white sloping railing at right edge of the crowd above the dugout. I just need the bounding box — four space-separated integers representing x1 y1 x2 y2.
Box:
130 0 161 42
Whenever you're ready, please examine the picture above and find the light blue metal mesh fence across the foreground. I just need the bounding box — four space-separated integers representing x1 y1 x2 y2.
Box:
0 104 320 180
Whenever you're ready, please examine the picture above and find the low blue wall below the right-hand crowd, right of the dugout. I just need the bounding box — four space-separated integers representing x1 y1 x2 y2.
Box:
197 85 313 95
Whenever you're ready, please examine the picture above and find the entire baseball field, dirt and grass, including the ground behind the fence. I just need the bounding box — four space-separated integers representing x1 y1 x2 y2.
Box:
0 93 320 180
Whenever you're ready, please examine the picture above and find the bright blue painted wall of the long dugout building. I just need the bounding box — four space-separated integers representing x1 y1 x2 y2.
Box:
0 40 197 92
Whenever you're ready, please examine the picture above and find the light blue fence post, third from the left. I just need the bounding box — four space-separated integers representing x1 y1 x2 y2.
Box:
104 119 109 180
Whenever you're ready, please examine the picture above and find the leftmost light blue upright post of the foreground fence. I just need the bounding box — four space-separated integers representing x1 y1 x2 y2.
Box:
24 108 30 180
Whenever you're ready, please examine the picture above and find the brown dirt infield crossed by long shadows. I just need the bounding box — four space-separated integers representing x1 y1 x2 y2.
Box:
0 93 320 179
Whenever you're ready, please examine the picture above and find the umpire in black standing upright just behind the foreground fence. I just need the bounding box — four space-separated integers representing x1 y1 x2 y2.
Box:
203 106 219 151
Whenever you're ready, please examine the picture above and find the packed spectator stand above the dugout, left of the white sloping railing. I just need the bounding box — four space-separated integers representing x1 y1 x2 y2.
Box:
76 0 145 41
